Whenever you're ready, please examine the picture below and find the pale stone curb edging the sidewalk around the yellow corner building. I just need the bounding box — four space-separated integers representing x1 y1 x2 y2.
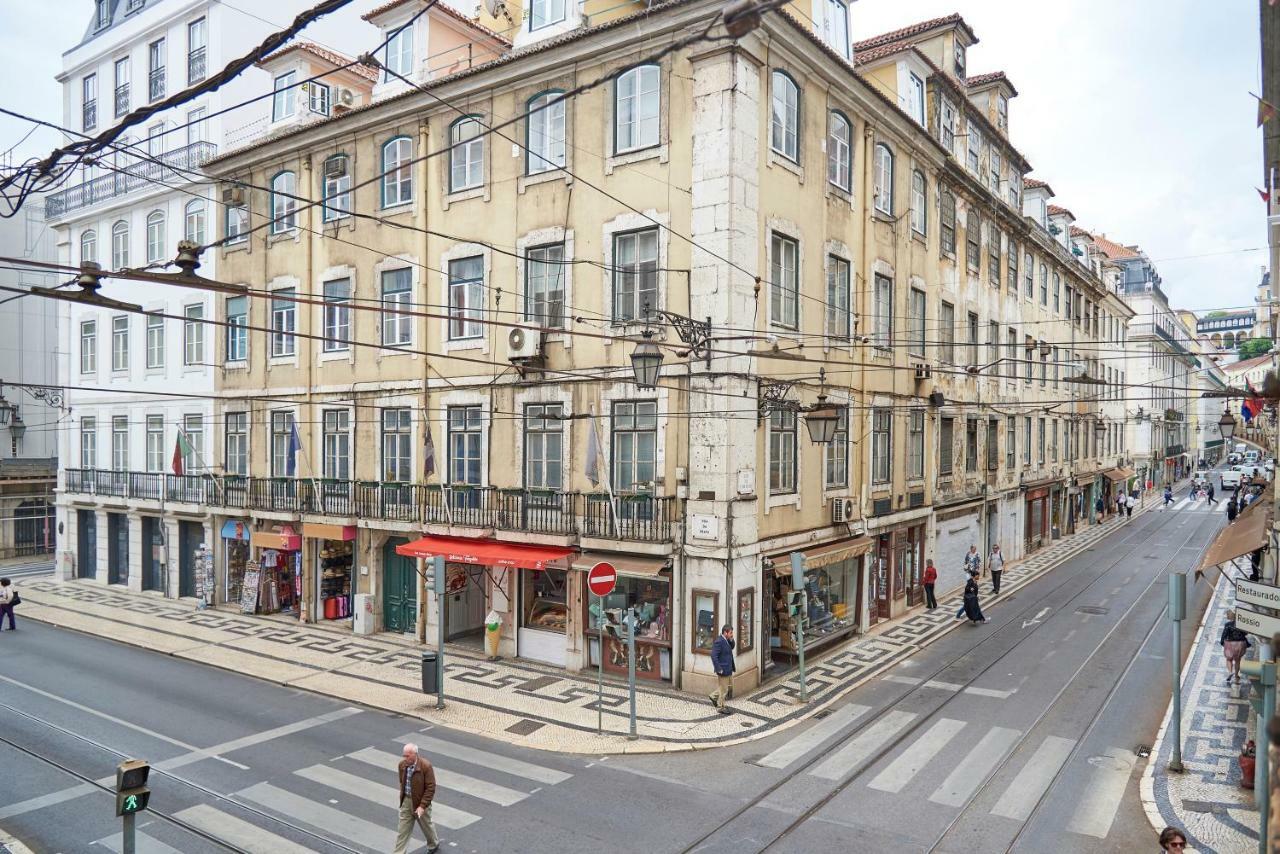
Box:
15 502 1157 755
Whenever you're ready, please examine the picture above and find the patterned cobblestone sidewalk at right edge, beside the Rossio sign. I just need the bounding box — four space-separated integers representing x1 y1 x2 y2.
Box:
1142 563 1258 854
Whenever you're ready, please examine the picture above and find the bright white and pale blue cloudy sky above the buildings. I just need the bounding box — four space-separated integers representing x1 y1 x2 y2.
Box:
0 0 1266 310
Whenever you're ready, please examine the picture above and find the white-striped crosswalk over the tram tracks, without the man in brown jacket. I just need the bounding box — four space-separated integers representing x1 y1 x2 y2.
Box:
755 705 1137 839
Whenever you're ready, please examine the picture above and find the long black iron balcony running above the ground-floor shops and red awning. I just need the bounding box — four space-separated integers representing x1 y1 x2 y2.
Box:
64 469 678 543
